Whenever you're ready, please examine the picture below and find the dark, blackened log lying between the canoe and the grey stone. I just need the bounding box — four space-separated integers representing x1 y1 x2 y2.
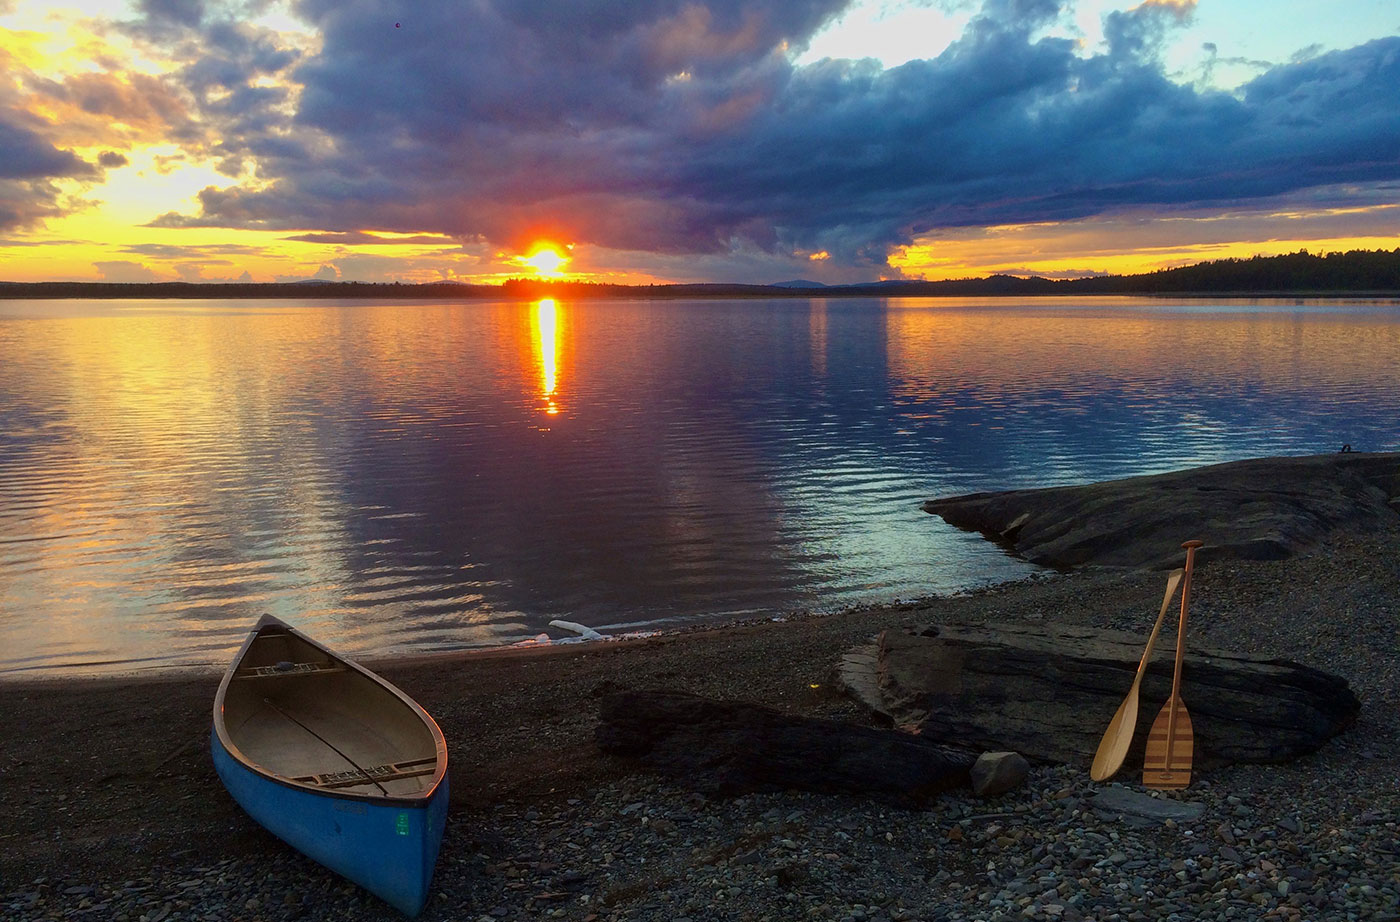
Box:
595 691 973 806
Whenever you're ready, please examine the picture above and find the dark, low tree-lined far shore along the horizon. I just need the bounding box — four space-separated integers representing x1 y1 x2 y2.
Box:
0 248 1400 301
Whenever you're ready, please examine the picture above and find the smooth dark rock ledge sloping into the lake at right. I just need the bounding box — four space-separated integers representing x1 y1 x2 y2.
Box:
923 452 1400 569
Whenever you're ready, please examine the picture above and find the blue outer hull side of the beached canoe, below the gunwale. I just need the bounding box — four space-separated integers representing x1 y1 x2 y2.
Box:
211 732 448 916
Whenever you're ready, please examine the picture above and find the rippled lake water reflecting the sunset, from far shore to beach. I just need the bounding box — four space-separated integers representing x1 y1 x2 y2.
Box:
0 298 1400 676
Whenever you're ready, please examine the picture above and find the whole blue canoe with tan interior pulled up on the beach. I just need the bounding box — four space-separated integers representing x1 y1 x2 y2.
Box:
211 616 447 915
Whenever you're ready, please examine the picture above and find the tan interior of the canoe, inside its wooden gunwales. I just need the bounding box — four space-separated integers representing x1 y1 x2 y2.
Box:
223 625 437 797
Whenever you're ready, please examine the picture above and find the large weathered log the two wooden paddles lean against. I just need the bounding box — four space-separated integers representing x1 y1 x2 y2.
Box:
840 624 1361 769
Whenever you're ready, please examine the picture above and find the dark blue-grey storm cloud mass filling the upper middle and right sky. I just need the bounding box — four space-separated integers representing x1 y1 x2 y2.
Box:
157 0 1400 264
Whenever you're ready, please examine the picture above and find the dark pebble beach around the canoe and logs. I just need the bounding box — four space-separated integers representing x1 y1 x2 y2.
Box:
0 532 1400 922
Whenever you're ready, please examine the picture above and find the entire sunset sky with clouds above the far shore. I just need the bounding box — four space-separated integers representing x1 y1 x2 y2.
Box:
0 0 1400 284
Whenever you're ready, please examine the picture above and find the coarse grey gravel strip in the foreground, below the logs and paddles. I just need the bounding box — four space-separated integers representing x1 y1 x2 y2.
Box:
0 767 1400 922
